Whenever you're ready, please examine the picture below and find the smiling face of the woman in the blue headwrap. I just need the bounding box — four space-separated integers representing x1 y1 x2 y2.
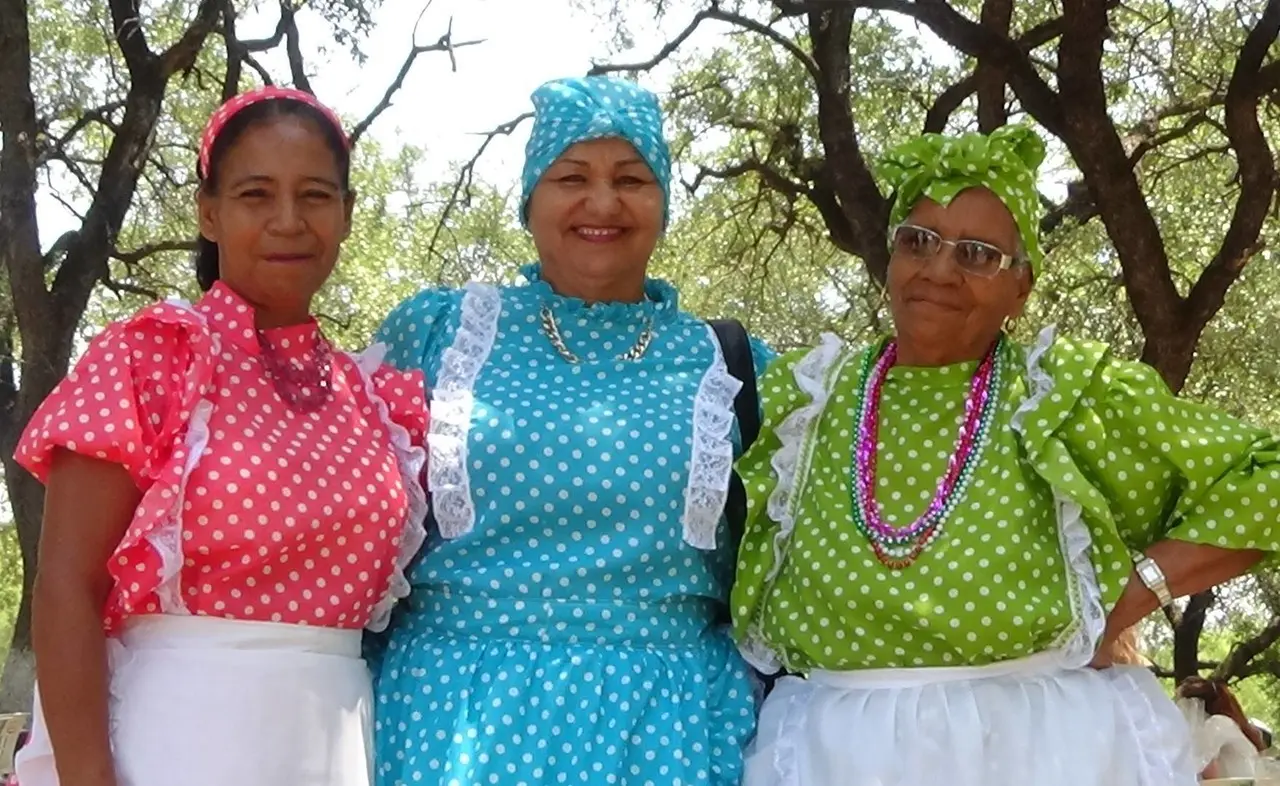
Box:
529 138 663 302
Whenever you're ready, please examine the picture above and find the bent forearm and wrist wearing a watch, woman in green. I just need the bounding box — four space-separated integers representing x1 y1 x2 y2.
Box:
1107 540 1263 634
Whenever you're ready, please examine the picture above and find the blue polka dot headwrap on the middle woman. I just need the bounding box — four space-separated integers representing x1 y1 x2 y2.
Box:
520 77 671 225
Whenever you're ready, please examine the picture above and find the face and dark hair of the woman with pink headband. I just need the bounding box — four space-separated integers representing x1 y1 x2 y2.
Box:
198 114 352 326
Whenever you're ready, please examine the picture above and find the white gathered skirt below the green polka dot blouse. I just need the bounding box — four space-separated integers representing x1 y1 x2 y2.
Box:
742 655 1197 786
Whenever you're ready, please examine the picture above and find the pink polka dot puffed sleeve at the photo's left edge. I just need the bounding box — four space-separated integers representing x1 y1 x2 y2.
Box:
14 317 188 489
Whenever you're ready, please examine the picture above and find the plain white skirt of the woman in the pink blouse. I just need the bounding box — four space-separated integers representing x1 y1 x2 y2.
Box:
15 616 372 786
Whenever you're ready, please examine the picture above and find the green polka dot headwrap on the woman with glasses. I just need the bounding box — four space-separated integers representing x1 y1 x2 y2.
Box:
877 125 1044 277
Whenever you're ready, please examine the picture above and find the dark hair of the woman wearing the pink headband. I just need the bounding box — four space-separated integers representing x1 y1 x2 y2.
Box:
195 99 351 292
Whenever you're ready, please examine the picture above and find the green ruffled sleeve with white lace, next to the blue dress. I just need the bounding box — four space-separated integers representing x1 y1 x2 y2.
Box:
732 335 844 673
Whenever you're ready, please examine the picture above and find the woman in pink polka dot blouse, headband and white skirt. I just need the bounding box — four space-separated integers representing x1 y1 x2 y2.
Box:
17 88 426 786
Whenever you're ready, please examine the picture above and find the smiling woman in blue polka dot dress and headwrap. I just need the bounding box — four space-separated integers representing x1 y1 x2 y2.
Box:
375 77 768 786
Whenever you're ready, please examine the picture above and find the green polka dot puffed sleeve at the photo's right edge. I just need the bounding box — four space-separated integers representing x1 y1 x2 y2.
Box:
1025 339 1280 608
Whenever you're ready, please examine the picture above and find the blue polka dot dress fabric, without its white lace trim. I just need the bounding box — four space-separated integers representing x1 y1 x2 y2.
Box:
375 269 754 786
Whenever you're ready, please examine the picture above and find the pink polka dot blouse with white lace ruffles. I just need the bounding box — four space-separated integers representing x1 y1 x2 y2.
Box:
17 284 428 631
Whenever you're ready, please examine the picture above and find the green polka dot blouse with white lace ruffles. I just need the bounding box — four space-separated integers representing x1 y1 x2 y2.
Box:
733 332 1280 671
